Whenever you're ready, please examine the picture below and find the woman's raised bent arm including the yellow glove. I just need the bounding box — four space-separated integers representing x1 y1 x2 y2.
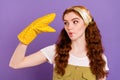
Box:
9 13 55 69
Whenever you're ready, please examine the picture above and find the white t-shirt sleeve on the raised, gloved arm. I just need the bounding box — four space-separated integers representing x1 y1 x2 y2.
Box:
40 44 55 64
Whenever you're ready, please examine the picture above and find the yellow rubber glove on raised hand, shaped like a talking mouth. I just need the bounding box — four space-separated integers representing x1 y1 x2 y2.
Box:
18 13 56 45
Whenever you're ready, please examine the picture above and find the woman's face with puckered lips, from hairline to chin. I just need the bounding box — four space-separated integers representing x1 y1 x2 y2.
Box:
64 12 86 41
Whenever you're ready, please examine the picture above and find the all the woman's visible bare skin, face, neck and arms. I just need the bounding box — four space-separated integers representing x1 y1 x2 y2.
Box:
9 12 106 80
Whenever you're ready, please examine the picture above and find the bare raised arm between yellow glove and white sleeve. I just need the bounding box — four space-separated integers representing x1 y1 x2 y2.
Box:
9 43 47 69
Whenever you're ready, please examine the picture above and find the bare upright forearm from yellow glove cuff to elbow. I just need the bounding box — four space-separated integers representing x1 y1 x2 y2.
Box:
9 43 27 68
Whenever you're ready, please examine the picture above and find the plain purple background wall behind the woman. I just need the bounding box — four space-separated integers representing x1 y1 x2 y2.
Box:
0 0 120 80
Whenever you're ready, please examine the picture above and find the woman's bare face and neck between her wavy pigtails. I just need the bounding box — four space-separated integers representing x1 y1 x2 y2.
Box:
64 12 87 58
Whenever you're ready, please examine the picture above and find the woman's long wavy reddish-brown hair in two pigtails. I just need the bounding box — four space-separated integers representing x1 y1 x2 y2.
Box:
54 6 107 78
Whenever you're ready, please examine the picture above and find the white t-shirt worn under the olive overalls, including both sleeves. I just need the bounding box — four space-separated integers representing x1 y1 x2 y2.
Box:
40 44 109 70
